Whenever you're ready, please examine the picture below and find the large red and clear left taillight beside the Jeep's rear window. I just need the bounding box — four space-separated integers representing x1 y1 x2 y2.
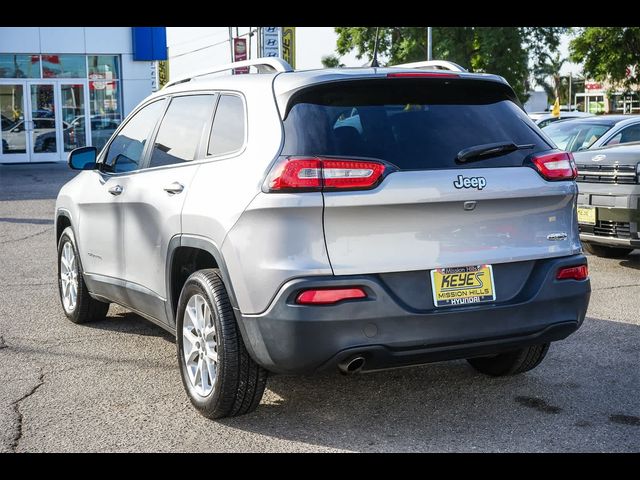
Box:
267 157 386 192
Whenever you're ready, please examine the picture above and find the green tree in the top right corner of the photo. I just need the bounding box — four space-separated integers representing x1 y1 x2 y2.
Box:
569 27 640 87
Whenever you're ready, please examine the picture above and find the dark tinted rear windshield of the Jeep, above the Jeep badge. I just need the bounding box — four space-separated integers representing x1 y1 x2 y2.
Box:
282 79 552 170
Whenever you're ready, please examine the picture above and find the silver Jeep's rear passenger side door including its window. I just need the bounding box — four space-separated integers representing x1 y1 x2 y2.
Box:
122 94 216 320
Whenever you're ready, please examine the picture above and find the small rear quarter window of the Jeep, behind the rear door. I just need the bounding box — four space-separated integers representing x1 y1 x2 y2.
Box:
207 95 245 155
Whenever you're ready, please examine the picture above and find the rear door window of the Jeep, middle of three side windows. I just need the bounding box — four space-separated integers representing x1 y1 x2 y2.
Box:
149 95 216 167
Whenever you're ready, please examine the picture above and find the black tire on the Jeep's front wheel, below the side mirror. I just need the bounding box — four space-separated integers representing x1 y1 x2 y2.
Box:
58 227 109 323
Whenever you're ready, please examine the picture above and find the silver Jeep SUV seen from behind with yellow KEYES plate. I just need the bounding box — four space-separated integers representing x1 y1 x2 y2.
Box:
55 59 590 418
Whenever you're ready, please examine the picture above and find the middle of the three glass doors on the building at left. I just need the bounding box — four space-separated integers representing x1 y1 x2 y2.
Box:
27 81 64 162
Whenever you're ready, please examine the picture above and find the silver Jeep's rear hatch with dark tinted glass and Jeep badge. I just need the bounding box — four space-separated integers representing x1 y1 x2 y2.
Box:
282 74 580 275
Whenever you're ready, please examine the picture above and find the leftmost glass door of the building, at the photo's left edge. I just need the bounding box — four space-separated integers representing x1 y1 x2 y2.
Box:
0 81 29 163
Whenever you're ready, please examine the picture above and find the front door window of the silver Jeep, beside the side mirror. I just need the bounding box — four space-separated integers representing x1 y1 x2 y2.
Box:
104 100 164 173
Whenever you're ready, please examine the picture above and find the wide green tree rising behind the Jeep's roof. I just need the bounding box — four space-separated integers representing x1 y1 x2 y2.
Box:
335 27 567 100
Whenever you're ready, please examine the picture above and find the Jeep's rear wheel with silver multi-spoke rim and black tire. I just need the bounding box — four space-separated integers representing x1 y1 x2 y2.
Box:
176 269 267 418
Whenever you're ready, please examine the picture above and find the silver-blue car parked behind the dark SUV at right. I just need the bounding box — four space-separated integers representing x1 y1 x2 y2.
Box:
542 115 640 152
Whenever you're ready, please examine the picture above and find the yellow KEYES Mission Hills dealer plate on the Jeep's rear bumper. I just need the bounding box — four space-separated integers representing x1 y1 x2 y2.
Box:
431 265 496 307
